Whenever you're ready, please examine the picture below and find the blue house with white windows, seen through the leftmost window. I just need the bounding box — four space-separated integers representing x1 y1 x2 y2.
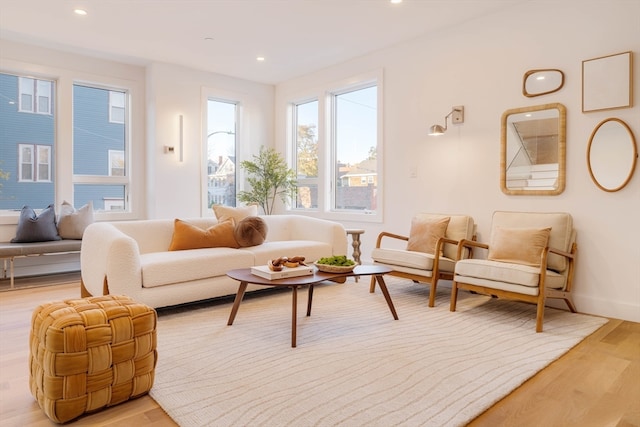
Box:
0 73 56 211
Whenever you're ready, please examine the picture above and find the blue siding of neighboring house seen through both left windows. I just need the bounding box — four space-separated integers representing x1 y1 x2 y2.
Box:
0 73 126 214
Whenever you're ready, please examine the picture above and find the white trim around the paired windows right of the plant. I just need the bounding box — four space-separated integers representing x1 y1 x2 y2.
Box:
286 69 384 223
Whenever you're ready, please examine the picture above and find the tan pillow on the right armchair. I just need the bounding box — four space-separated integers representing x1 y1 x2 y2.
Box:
487 227 551 267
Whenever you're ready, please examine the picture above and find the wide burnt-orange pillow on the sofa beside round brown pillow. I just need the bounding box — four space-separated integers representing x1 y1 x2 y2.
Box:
169 219 240 251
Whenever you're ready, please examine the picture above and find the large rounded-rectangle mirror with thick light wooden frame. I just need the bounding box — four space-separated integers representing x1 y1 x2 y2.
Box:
500 103 567 195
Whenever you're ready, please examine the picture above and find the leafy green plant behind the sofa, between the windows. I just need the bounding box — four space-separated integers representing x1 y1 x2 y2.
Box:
238 146 298 215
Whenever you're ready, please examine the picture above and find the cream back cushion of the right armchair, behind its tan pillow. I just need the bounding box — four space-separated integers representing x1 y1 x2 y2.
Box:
491 211 576 272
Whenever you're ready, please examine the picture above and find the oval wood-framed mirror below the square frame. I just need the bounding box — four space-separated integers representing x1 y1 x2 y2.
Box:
587 118 638 192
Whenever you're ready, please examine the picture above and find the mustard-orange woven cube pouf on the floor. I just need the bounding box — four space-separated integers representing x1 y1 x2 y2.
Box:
29 295 157 423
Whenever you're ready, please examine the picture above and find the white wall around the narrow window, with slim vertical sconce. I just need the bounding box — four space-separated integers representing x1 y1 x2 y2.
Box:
146 64 274 218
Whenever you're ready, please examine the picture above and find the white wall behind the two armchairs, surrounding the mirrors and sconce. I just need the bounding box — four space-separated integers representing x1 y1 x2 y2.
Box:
276 0 640 321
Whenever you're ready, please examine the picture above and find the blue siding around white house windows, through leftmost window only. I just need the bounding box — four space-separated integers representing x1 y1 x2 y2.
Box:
0 74 55 209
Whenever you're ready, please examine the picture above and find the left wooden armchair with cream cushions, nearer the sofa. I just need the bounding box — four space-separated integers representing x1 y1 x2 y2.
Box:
370 213 475 307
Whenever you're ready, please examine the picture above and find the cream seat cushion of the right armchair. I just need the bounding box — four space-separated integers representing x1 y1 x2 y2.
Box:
454 259 566 295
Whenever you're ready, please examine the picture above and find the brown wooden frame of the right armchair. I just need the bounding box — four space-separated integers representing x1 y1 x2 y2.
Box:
450 239 578 332
